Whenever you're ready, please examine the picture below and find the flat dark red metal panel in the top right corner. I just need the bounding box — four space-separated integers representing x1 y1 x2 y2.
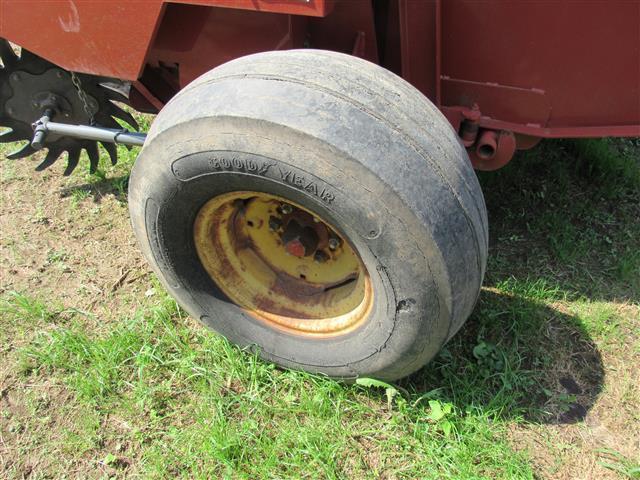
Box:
442 0 640 128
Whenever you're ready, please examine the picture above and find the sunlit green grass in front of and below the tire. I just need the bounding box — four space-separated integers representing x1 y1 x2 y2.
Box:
9 290 532 478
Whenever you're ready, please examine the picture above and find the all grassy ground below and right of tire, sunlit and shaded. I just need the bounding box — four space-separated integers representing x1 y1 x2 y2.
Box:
0 134 640 479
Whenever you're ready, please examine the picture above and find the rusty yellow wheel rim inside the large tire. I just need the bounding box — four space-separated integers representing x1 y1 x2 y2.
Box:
193 191 373 337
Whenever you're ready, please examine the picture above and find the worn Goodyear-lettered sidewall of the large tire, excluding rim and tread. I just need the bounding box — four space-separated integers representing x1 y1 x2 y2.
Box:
129 117 450 379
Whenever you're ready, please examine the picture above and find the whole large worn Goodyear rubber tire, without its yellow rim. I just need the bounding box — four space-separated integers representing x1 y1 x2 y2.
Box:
129 50 488 380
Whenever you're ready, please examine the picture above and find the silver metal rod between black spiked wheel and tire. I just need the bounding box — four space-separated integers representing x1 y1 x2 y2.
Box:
31 113 147 149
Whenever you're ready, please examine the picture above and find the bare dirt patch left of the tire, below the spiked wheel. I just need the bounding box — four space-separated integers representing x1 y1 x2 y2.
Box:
0 159 151 328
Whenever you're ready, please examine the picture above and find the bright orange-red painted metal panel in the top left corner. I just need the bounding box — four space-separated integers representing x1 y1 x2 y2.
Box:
0 0 162 80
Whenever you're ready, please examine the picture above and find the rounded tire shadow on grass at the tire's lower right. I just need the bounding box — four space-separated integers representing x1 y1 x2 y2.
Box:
400 290 604 423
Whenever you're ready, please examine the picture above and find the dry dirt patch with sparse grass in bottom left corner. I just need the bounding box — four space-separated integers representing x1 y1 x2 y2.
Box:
0 366 136 479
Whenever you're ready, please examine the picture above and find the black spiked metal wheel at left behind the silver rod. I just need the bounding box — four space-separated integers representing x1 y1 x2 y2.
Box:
0 38 139 175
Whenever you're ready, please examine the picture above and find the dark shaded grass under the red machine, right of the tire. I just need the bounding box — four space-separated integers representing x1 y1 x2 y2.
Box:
479 139 640 303
